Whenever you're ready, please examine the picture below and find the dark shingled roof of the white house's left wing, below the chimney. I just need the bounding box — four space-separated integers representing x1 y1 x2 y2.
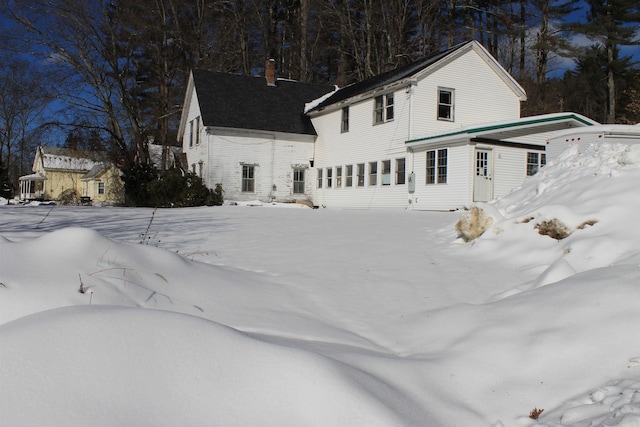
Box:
193 70 334 135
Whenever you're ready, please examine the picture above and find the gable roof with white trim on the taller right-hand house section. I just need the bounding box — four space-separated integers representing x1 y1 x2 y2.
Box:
308 40 526 112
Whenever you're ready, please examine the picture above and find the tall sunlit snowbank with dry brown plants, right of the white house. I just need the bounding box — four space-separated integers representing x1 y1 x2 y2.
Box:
462 143 640 284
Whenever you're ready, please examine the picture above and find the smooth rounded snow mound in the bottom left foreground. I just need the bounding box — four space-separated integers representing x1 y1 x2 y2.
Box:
0 306 410 426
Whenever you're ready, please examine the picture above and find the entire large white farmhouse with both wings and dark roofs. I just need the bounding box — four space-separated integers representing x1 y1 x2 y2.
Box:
179 41 597 210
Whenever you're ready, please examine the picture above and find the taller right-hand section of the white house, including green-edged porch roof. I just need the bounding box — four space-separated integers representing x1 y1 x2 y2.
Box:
308 41 596 210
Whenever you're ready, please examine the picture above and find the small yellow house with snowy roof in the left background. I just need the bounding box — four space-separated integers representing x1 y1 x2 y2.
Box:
20 147 124 203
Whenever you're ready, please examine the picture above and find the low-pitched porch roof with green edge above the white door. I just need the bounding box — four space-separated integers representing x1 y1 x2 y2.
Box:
405 113 599 148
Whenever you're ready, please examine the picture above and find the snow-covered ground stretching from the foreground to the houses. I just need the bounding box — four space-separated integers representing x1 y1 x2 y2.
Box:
0 145 640 427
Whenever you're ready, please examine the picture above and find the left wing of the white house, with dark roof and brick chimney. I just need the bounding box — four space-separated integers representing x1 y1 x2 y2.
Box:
178 61 333 201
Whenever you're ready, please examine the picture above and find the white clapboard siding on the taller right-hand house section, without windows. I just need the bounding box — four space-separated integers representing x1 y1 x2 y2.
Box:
312 43 524 210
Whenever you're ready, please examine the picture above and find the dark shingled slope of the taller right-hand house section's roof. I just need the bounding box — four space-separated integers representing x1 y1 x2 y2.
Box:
310 42 470 111
